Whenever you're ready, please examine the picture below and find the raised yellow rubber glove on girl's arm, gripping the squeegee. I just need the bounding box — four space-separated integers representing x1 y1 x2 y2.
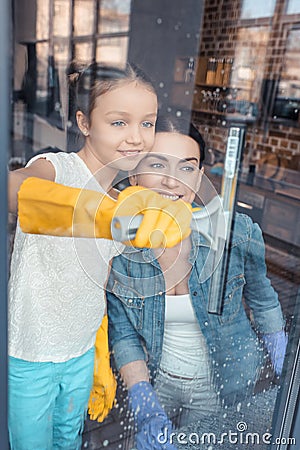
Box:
18 178 192 247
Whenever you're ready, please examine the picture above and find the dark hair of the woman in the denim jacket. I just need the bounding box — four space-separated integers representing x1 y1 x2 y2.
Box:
155 115 205 168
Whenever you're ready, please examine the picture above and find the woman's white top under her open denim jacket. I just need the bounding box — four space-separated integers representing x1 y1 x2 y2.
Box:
160 294 209 379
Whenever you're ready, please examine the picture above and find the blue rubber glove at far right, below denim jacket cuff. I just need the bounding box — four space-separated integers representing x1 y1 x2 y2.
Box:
262 330 288 376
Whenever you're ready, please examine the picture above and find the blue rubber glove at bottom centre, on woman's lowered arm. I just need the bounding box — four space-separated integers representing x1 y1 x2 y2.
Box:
128 381 176 450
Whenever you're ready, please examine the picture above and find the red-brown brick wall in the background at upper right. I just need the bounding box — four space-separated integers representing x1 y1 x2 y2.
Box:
193 0 300 176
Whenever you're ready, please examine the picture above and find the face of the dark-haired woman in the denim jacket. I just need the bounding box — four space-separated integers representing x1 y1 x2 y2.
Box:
130 133 203 203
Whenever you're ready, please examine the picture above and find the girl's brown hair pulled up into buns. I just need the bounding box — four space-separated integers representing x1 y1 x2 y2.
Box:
67 62 156 120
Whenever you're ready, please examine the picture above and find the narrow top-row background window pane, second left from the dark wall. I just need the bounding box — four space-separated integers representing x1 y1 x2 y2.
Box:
73 0 95 36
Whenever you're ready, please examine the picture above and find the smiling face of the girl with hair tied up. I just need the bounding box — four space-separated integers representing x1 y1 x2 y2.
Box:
77 82 157 170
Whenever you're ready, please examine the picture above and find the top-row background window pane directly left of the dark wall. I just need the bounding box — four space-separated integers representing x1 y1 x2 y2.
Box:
98 0 131 33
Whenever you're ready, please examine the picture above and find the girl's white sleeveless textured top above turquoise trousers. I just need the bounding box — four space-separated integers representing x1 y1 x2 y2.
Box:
9 152 123 362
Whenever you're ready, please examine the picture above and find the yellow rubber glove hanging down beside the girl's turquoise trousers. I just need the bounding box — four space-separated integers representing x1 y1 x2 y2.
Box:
88 315 117 422
